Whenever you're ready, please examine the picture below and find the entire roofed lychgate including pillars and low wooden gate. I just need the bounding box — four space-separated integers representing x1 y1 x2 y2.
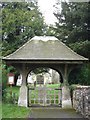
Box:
3 36 88 107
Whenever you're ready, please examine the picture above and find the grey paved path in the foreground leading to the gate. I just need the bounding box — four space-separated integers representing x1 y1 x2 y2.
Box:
29 107 88 120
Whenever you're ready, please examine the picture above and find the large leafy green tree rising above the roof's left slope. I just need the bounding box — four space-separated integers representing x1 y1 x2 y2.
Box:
2 2 45 56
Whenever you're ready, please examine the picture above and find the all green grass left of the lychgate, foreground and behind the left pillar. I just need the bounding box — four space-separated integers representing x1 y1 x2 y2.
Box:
2 86 30 118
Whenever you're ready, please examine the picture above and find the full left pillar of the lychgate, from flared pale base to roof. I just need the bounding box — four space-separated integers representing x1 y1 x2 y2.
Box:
18 64 28 107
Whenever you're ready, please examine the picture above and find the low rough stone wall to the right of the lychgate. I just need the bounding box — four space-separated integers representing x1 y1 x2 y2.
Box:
73 86 90 119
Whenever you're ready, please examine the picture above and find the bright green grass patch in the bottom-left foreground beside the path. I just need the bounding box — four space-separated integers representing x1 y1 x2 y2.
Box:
2 103 30 118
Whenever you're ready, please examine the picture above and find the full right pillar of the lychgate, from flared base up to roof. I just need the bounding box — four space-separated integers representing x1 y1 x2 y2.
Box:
62 64 72 108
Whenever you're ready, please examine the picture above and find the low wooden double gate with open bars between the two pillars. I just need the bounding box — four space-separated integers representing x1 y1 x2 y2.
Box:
28 85 62 107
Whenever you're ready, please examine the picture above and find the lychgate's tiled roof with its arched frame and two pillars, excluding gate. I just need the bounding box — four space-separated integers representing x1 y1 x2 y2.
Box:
3 36 88 107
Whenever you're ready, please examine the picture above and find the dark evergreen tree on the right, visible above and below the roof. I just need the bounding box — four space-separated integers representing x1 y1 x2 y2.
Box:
54 2 90 85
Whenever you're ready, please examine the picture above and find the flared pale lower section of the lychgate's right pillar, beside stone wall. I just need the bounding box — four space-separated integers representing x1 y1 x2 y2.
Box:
62 86 72 108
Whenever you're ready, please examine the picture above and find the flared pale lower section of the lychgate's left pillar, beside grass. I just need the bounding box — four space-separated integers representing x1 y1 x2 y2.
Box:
18 86 28 107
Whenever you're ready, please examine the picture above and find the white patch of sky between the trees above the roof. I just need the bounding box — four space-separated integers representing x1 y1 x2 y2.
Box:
38 0 57 25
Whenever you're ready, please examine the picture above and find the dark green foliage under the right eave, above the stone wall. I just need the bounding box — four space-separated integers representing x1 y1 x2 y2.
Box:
68 64 90 85
